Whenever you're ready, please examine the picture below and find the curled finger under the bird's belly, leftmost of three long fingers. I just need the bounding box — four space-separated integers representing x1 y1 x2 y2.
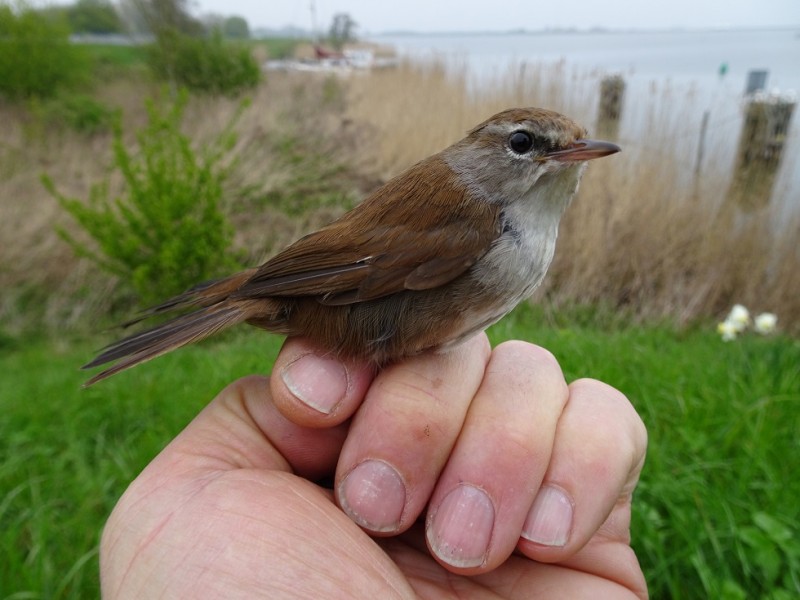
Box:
336 334 490 534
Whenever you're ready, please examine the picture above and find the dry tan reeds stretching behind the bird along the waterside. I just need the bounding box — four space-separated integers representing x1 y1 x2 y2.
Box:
0 60 800 333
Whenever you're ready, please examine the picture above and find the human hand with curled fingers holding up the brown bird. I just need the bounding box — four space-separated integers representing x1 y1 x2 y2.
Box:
100 335 647 598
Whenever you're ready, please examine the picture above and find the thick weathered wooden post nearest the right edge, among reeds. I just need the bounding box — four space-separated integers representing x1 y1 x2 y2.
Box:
731 94 797 210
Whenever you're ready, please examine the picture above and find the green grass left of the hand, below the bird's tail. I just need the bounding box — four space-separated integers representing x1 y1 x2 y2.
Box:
0 336 280 599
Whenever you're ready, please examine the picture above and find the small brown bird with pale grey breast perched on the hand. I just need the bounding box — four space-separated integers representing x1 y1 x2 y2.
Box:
83 108 620 386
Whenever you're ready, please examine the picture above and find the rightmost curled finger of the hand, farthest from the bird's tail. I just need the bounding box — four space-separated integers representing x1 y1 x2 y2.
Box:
519 379 647 576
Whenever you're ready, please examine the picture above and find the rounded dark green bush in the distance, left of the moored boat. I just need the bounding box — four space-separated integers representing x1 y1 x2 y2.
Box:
148 30 261 95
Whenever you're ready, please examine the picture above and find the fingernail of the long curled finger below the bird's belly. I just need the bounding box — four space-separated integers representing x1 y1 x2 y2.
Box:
339 460 406 532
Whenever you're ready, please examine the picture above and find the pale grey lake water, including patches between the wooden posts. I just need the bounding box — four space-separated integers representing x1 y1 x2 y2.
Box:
372 27 800 216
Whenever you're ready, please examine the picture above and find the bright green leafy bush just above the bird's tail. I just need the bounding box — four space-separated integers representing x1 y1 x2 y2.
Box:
43 94 241 303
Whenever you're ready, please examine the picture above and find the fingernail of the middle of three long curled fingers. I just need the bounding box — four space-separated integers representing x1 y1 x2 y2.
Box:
427 484 494 567
